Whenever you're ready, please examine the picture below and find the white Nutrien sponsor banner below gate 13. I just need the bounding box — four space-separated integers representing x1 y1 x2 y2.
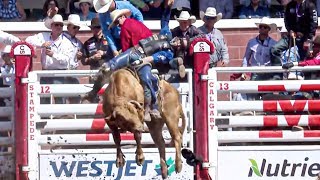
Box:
218 150 320 180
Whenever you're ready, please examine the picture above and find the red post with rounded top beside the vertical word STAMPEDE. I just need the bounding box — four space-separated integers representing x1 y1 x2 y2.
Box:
10 42 34 180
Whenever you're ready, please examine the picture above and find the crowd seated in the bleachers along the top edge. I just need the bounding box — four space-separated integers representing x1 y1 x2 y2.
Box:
0 0 320 21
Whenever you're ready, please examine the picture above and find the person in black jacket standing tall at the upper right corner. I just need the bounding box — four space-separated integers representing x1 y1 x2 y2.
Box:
271 0 318 69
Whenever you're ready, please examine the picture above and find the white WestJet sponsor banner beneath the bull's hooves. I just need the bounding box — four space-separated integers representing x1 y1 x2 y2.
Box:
40 153 193 180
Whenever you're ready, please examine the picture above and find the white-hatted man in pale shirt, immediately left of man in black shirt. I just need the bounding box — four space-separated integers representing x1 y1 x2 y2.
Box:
63 14 83 104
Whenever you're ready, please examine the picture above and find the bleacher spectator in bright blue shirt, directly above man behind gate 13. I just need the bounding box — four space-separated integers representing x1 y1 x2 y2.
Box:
239 0 270 19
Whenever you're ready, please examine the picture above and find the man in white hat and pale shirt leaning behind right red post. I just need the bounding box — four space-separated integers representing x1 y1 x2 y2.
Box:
199 7 229 67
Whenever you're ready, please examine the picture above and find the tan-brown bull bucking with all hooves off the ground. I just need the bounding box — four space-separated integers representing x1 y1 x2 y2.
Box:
98 69 185 178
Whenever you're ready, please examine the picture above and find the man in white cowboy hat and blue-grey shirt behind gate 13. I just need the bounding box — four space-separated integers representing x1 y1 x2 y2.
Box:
242 17 277 81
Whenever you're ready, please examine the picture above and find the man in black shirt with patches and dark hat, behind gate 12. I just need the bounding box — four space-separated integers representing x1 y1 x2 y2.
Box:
81 18 112 78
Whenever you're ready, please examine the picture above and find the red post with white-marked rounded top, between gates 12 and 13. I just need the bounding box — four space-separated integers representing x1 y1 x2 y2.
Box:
189 38 214 179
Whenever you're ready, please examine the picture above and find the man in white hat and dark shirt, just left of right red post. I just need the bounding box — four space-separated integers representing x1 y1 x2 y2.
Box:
170 11 200 69
